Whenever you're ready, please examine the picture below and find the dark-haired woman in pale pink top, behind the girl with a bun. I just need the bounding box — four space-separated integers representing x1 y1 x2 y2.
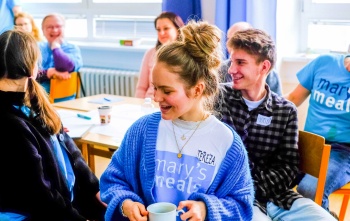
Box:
135 12 184 99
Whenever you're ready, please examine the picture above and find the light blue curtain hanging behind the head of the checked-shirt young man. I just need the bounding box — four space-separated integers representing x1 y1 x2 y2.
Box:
215 0 277 57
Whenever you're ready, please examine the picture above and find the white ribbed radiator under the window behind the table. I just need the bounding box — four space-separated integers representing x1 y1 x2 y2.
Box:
79 67 139 97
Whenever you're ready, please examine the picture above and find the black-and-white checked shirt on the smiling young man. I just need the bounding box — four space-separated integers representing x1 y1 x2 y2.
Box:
216 83 302 212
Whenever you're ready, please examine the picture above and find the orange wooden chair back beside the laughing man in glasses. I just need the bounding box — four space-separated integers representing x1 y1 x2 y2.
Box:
49 72 80 103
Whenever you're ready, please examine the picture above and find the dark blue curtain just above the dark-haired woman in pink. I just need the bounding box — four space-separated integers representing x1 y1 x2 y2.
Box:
162 0 202 23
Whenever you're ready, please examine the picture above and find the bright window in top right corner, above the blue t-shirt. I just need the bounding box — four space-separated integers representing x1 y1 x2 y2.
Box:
300 0 350 53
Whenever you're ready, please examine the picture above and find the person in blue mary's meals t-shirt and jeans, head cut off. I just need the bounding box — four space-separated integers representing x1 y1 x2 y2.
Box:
285 54 350 219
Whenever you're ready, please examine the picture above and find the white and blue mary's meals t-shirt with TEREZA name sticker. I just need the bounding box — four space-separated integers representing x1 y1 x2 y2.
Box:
153 115 233 205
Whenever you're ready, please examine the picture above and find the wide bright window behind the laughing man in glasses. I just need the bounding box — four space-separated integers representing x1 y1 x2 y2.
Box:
22 0 162 45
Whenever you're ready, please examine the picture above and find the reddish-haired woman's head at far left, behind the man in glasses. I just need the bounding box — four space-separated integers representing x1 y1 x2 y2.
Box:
14 12 43 42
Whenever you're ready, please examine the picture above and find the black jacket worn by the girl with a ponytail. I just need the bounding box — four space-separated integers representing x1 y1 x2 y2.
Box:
0 91 105 221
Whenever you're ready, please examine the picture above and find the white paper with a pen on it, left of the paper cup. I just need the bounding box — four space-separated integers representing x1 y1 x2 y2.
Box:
57 109 99 138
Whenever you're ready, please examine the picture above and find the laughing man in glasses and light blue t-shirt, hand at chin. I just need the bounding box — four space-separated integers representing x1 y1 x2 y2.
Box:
37 13 83 102
